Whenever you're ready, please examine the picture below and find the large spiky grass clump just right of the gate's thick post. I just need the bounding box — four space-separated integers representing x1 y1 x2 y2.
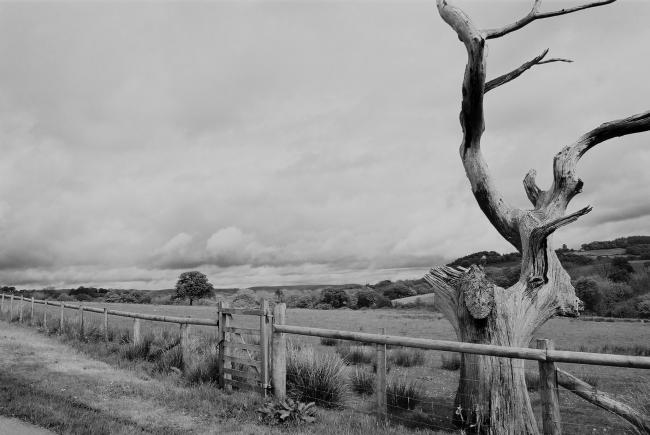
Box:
287 345 349 407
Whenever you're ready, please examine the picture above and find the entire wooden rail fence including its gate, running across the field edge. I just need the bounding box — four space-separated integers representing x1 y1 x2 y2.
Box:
0 294 650 435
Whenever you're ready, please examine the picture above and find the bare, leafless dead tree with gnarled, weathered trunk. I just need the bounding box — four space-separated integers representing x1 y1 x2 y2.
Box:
425 0 650 435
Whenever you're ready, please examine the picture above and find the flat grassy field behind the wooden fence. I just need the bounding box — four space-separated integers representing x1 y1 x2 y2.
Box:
10 303 650 434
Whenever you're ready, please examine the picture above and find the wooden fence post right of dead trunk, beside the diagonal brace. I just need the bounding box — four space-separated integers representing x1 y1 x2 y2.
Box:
537 339 562 435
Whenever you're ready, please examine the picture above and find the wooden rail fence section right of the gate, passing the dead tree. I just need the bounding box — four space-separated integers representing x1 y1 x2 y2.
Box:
272 304 650 435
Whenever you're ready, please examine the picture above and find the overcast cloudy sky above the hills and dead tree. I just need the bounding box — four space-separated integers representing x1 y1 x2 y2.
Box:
0 0 650 289
